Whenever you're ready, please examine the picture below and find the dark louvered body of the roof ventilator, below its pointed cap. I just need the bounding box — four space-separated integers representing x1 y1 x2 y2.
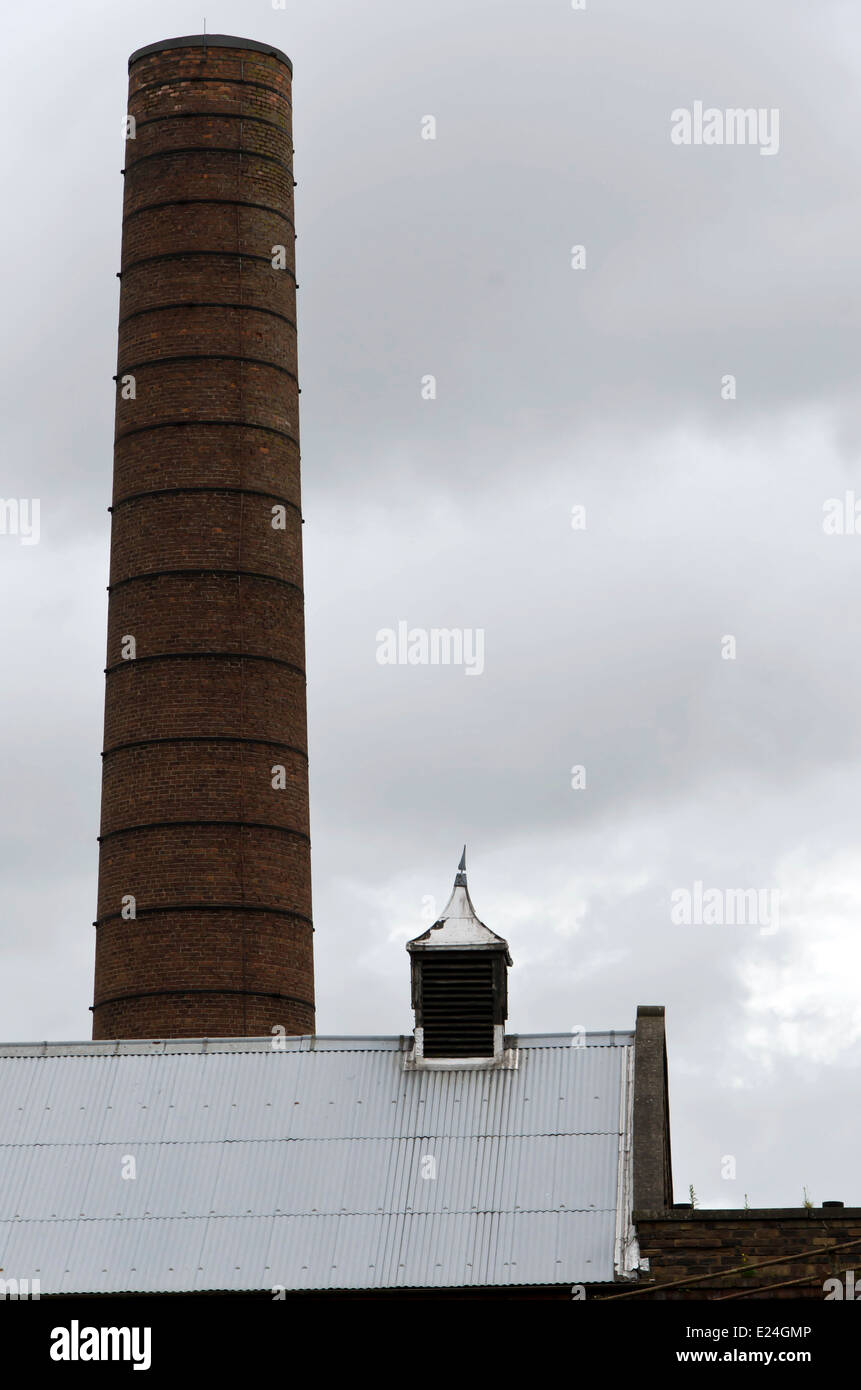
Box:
420 951 495 1056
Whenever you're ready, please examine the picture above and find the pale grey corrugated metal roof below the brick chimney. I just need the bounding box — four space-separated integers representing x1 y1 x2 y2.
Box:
0 1033 633 1294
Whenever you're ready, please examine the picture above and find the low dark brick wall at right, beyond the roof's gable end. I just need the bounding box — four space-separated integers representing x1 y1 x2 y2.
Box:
634 1207 861 1301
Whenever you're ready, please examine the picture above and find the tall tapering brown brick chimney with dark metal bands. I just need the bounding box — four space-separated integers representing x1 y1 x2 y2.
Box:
93 35 314 1038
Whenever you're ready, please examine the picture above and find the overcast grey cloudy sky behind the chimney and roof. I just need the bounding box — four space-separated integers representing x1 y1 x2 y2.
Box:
0 0 861 1207
